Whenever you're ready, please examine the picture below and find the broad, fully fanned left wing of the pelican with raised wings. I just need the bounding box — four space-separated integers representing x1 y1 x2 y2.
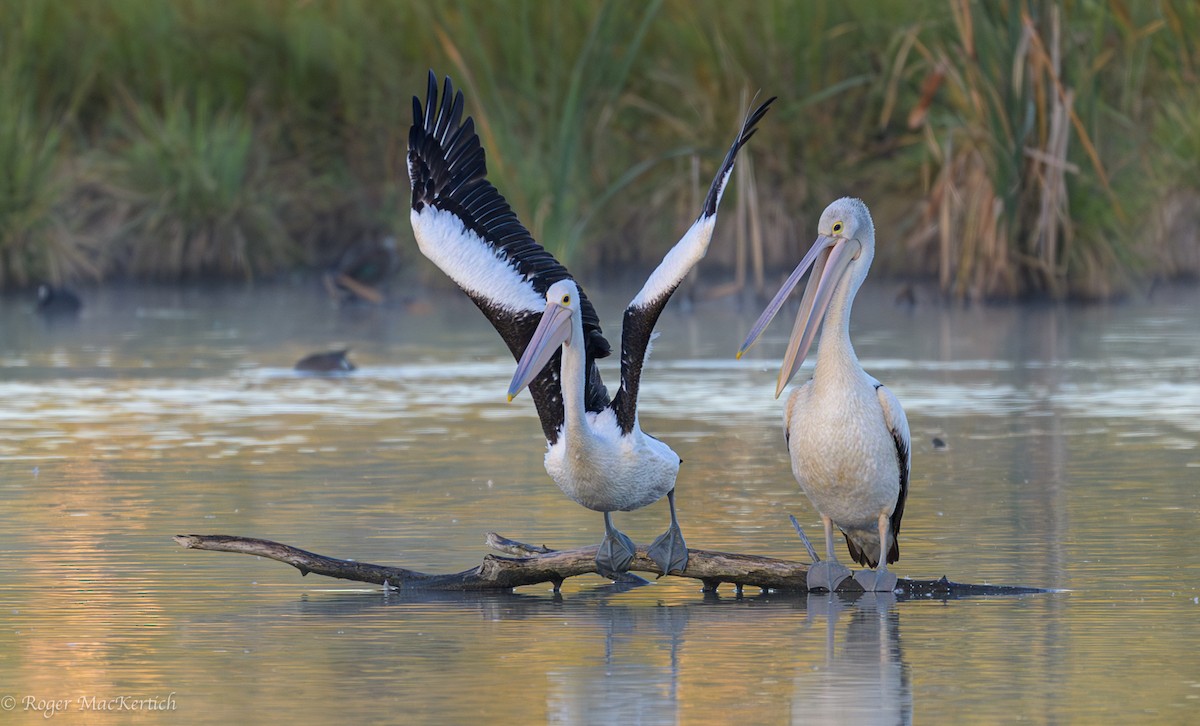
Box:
408 71 610 443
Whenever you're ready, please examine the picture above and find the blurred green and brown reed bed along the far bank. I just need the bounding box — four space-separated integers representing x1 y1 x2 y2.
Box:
0 0 1200 300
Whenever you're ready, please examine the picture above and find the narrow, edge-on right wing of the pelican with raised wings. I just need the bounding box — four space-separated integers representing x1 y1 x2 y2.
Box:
613 97 775 433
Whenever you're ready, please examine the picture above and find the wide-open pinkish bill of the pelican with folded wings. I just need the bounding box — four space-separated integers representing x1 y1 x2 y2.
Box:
738 234 863 398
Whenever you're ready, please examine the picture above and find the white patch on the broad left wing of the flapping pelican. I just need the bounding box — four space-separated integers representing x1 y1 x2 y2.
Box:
409 204 546 312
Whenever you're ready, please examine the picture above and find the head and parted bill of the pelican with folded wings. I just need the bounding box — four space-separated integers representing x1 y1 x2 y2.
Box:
738 197 875 398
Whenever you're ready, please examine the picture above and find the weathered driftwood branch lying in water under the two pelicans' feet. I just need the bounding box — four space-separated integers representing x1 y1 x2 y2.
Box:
175 533 1045 598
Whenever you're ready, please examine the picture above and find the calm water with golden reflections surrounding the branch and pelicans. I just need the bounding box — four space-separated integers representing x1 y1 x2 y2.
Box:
0 282 1200 724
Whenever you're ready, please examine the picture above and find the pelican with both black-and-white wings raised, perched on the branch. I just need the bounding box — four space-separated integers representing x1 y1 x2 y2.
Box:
408 71 774 578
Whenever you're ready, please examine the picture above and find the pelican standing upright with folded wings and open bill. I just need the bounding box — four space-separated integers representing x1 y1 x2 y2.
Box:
738 197 910 592
